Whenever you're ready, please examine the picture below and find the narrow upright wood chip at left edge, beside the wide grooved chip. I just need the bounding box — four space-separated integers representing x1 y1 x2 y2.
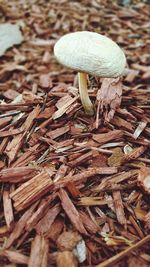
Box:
3 190 14 228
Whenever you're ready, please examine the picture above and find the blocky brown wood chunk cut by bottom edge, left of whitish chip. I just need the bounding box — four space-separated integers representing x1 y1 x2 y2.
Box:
56 251 78 267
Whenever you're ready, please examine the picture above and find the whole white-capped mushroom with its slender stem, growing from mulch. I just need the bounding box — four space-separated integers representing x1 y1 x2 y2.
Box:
54 31 126 115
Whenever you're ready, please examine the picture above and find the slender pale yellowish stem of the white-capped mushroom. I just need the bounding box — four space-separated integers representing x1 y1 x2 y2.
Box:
78 72 94 115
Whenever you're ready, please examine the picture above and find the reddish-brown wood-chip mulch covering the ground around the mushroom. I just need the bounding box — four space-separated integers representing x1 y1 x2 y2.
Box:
0 0 150 267
